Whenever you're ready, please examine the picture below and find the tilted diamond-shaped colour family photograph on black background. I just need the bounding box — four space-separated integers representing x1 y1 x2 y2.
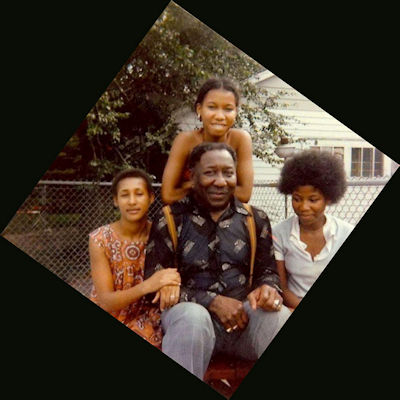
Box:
2 2 398 398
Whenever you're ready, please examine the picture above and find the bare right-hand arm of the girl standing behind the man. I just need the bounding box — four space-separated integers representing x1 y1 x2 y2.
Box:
235 130 254 203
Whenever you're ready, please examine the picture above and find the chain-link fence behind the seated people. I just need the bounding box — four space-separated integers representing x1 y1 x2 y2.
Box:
2 180 387 296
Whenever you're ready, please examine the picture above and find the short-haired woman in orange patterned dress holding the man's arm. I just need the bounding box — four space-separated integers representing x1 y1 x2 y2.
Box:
89 169 180 348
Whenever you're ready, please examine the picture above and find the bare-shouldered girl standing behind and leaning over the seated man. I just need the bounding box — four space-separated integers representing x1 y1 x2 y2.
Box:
161 78 254 204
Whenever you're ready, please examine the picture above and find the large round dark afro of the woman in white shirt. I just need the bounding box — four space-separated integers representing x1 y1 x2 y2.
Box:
278 150 347 203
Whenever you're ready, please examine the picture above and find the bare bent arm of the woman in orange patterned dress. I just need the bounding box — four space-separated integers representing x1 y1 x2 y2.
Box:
89 238 180 312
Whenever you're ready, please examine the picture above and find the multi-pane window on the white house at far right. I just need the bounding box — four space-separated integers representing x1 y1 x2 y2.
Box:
351 147 383 178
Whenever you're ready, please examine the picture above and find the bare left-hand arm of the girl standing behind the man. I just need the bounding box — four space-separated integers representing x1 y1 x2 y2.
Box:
161 132 193 204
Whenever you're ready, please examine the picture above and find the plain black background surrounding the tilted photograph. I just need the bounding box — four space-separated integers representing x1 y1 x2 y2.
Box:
0 0 400 399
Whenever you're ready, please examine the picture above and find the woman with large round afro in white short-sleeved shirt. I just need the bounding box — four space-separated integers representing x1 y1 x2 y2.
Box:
273 150 354 308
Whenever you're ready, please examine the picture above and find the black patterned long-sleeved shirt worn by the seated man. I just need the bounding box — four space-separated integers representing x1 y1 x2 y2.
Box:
145 197 280 308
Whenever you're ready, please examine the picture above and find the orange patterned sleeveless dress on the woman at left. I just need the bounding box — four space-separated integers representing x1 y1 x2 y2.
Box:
89 225 162 348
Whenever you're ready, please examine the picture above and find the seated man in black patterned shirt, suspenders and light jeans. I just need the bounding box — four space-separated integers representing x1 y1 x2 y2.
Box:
145 143 290 379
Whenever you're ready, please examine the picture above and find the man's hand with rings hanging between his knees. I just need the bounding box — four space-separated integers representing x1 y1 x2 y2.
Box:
209 296 249 332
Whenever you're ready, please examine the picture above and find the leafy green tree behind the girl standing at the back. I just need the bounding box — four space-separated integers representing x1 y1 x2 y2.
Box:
46 2 289 180
